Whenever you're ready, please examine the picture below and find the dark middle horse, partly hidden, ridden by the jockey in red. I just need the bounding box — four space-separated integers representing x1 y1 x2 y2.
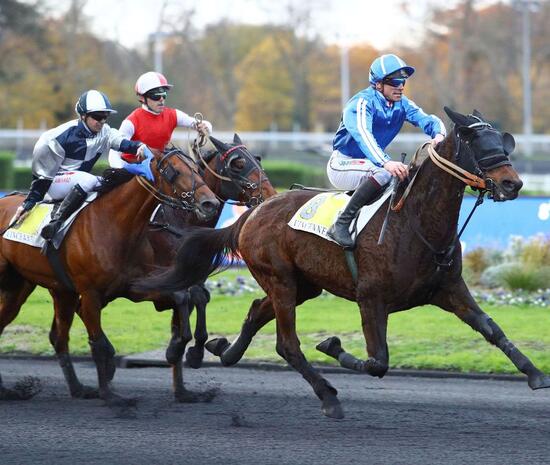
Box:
44 134 276 402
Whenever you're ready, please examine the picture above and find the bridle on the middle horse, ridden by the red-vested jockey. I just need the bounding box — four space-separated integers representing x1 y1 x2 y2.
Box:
193 139 267 207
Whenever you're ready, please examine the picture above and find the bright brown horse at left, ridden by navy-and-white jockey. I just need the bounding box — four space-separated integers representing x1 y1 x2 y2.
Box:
0 147 219 405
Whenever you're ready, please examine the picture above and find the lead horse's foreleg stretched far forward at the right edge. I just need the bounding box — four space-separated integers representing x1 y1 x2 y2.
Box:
431 279 550 389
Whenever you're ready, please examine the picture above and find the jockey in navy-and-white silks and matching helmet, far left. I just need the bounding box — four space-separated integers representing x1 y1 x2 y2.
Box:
15 90 147 239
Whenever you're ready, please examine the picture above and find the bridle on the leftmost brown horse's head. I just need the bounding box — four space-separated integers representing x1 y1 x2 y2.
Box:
137 149 205 211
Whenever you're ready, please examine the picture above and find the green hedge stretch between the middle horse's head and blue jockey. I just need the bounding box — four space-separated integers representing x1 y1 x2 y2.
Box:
262 160 329 189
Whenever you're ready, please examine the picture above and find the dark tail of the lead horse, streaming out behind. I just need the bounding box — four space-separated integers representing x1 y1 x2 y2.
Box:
131 209 253 294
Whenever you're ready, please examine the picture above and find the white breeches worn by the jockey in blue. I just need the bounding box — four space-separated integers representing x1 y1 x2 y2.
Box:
327 150 391 190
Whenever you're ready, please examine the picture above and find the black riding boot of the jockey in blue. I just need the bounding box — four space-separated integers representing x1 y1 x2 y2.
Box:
327 178 381 249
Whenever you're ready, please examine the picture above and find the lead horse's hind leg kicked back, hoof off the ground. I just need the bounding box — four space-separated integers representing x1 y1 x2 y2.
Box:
206 297 275 366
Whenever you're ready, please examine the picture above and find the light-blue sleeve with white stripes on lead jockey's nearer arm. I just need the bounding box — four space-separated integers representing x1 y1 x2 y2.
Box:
343 97 391 166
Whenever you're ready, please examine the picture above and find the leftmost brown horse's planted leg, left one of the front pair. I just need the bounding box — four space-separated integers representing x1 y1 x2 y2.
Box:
50 290 99 399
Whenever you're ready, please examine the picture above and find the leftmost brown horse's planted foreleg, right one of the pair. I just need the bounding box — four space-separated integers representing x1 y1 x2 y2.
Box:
80 292 136 407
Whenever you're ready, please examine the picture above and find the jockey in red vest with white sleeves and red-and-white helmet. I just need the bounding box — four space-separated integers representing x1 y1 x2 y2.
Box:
109 71 212 168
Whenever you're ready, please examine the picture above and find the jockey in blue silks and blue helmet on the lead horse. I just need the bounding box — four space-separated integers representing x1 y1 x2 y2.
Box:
327 54 446 248
